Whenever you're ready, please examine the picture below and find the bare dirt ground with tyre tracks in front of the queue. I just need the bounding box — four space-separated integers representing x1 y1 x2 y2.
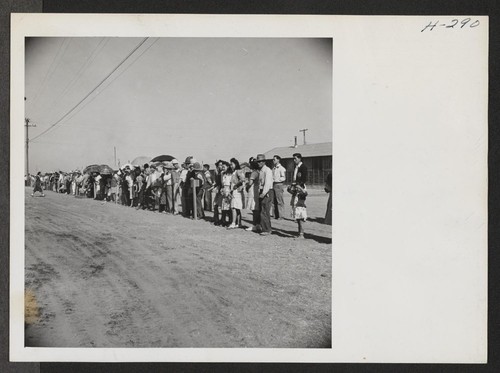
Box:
25 188 332 348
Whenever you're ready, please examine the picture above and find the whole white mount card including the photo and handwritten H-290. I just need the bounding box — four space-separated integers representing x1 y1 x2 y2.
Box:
9 13 489 363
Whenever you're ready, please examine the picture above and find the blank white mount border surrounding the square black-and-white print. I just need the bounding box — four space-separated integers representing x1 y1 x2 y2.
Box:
10 13 488 363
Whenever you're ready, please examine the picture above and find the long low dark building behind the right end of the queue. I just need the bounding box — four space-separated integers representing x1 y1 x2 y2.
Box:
264 142 333 187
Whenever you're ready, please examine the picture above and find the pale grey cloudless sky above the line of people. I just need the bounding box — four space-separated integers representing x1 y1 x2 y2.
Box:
25 37 332 173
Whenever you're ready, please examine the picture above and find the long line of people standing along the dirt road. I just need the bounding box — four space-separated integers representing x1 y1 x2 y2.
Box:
32 153 331 238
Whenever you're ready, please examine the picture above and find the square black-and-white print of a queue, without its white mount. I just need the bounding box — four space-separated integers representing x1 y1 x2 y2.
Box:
24 37 332 348
